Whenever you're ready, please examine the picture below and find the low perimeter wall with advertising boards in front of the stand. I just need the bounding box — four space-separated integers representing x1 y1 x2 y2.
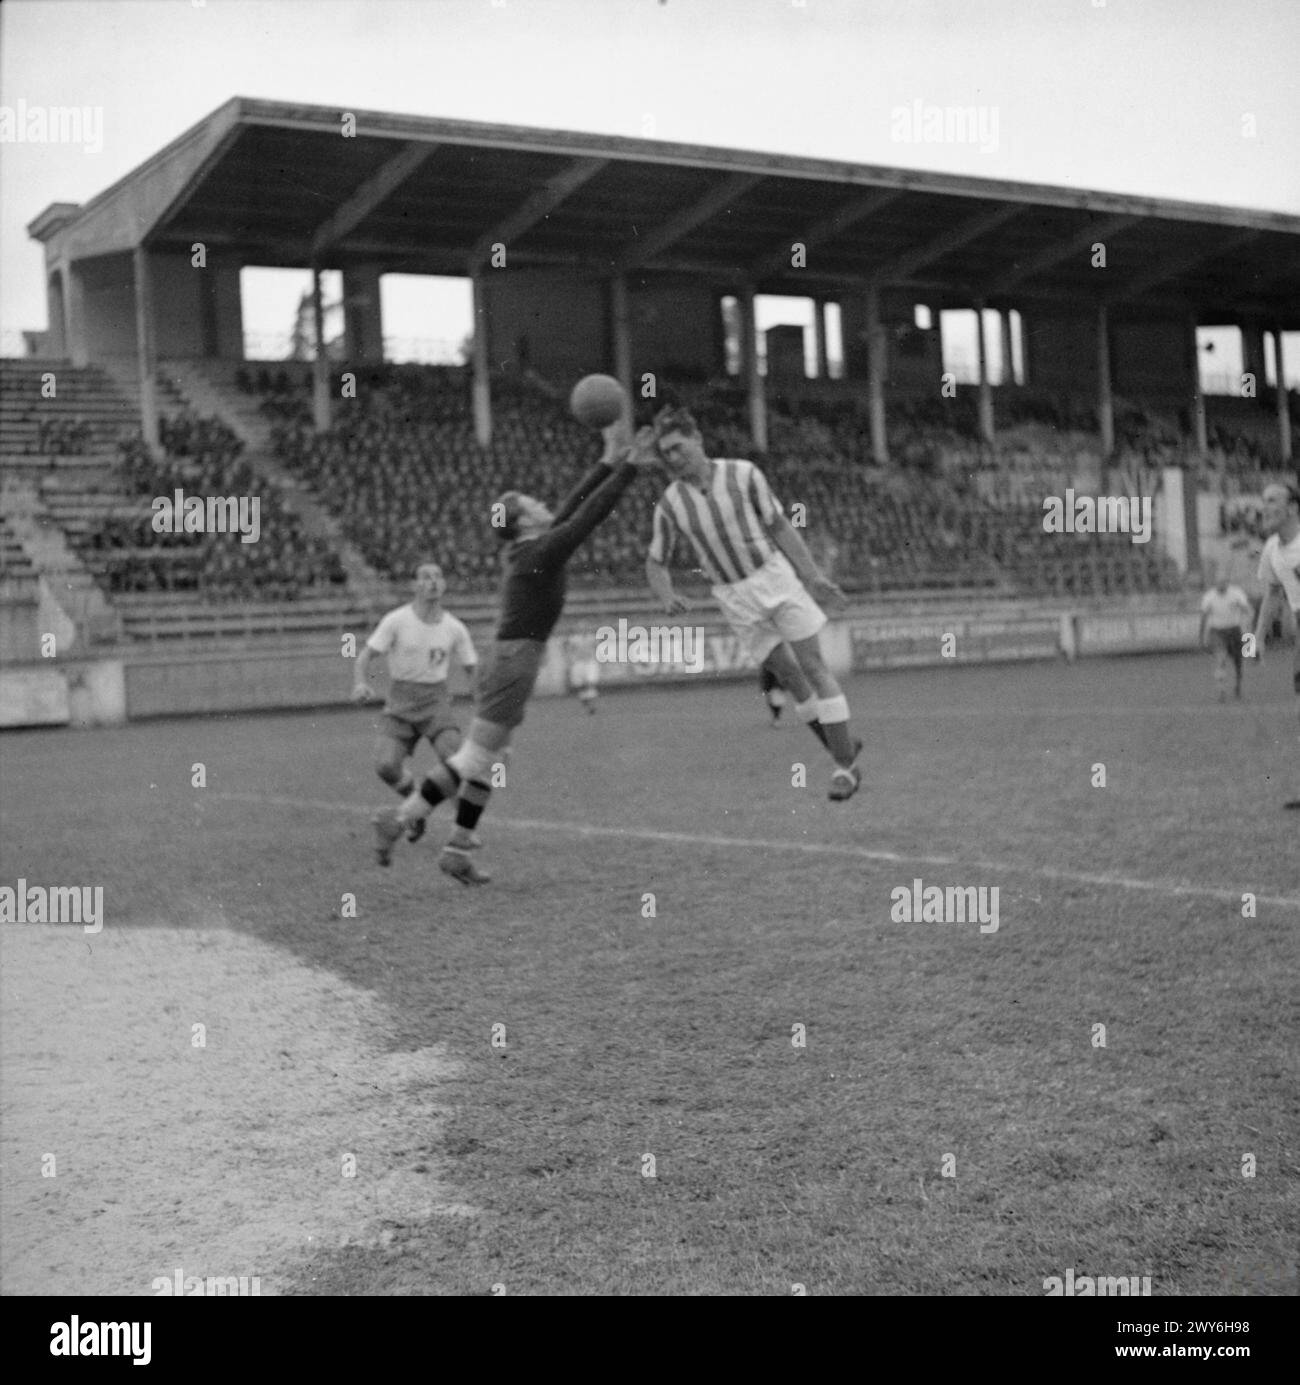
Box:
0 598 1199 727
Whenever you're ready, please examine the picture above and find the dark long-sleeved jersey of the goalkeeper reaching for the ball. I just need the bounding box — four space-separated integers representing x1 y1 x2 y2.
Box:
497 463 637 640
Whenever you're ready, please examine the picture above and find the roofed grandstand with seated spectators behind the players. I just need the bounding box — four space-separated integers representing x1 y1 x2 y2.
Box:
0 100 1300 714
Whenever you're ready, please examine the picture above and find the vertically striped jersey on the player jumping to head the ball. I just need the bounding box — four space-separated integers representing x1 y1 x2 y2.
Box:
649 457 782 586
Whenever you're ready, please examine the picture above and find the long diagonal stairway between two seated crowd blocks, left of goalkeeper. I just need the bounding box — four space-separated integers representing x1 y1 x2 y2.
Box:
148 360 388 605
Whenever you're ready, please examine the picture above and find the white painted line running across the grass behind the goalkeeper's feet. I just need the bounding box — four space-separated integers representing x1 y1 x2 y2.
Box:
206 792 1300 909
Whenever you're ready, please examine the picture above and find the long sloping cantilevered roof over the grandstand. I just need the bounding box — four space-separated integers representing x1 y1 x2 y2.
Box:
28 97 1300 330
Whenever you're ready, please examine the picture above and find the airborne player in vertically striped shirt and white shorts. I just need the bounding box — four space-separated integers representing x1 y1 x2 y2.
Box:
645 409 863 801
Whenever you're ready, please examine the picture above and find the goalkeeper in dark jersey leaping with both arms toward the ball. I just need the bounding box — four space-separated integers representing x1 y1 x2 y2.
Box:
374 422 656 885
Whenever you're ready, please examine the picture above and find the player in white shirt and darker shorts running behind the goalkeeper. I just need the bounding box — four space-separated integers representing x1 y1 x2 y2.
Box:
352 562 479 842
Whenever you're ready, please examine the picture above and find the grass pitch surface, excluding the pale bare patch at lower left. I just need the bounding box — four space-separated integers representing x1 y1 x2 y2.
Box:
0 656 1300 1295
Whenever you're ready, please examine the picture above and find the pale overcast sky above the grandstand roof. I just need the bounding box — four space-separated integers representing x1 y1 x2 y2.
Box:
0 0 1300 371
